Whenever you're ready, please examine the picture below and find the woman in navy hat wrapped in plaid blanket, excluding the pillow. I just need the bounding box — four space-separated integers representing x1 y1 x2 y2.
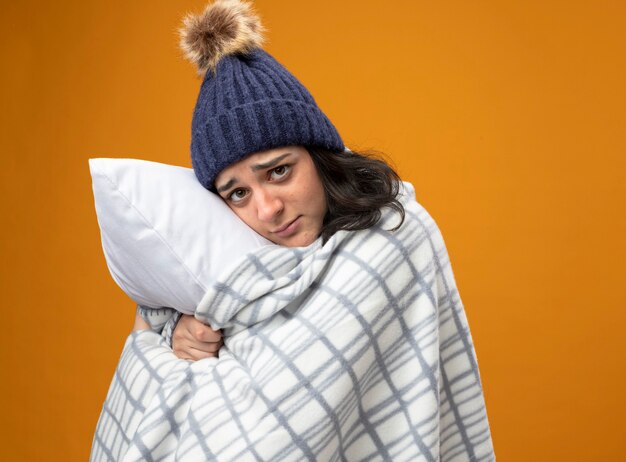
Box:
97 0 494 461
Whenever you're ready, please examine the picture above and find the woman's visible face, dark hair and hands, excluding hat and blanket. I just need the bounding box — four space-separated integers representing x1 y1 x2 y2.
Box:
134 146 404 360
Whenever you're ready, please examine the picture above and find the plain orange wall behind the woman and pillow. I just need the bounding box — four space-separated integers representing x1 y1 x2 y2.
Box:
0 0 626 461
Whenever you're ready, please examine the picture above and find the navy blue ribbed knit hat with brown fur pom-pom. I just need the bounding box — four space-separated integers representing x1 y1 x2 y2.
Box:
180 0 344 189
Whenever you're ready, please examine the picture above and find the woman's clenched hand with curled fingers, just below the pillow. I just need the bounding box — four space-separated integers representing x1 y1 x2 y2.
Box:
172 314 224 361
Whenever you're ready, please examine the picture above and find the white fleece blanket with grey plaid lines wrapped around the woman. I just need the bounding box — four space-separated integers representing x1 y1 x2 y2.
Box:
91 185 495 461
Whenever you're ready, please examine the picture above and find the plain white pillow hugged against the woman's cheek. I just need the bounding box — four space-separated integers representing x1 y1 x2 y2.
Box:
89 159 271 314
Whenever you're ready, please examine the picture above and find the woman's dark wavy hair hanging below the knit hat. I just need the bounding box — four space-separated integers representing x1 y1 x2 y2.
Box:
305 146 404 242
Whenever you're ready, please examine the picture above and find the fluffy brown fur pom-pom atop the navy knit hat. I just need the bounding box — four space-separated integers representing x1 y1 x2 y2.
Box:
179 0 264 76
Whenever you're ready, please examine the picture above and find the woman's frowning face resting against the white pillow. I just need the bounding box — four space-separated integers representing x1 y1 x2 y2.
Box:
215 146 327 247
